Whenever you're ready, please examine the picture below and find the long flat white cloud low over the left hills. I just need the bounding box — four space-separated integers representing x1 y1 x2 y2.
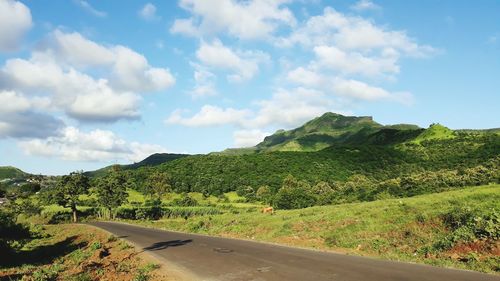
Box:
19 127 166 162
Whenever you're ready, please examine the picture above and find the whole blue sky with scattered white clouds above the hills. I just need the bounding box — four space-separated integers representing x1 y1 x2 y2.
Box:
0 0 500 175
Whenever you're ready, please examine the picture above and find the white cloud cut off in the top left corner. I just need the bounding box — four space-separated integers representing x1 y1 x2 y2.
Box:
0 0 32 52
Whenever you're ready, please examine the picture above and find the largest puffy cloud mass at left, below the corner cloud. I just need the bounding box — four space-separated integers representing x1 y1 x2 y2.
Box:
0 30 175 122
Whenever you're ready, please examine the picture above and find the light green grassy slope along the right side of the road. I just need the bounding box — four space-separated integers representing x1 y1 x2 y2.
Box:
128 185 500 272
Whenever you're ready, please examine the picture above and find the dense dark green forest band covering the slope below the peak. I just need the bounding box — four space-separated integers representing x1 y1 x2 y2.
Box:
119 133 500 201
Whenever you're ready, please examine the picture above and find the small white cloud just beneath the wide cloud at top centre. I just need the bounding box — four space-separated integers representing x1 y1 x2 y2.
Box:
196 40 269 82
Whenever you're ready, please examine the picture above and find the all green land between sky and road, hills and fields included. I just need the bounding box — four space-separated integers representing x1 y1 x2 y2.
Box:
0 113 500 272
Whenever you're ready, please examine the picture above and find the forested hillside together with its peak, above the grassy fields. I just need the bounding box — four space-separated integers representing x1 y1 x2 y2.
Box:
116 113 500 203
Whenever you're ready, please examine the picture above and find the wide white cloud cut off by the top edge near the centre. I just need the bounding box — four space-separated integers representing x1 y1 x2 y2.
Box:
170 0 295 39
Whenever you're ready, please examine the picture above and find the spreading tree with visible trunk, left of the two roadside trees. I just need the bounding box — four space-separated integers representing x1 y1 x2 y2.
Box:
47 171 90 222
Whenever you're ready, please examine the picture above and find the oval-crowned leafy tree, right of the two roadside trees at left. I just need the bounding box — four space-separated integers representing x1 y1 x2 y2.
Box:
95 166 128 218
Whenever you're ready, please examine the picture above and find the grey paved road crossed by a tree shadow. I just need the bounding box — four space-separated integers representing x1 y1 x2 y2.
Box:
92 222 500 281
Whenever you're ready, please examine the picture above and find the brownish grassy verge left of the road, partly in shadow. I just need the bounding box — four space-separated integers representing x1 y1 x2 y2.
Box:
0 222 169 281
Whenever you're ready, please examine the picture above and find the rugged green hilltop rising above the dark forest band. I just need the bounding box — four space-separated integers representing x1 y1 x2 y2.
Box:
218 112 482 155
